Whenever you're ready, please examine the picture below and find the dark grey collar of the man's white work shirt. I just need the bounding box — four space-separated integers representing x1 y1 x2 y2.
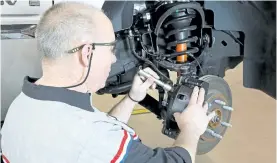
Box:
22 76 94 111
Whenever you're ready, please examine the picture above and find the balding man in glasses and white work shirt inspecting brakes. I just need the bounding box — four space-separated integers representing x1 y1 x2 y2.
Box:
1 2 213 163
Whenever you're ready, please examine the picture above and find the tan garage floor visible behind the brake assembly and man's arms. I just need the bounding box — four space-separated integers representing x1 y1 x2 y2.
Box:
93 64 276 163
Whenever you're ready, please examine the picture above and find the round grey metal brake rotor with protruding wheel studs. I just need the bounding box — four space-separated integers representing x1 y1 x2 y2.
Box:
197 75 232 155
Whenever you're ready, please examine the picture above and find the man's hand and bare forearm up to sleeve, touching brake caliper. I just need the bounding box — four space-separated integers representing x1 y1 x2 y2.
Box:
174 87 215 163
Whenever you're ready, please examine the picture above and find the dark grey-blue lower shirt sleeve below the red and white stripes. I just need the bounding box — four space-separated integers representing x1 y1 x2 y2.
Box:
125 141 192 163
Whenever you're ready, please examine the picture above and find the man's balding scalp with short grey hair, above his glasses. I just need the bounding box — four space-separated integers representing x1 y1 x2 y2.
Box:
36 2 111 59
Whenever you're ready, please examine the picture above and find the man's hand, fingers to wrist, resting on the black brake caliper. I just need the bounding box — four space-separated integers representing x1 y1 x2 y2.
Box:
174 87 215 137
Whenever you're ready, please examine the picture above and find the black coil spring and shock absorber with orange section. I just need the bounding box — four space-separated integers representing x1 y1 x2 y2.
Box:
155 2 205 72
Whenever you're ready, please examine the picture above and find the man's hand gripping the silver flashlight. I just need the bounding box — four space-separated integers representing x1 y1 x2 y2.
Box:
126 67 157 102
